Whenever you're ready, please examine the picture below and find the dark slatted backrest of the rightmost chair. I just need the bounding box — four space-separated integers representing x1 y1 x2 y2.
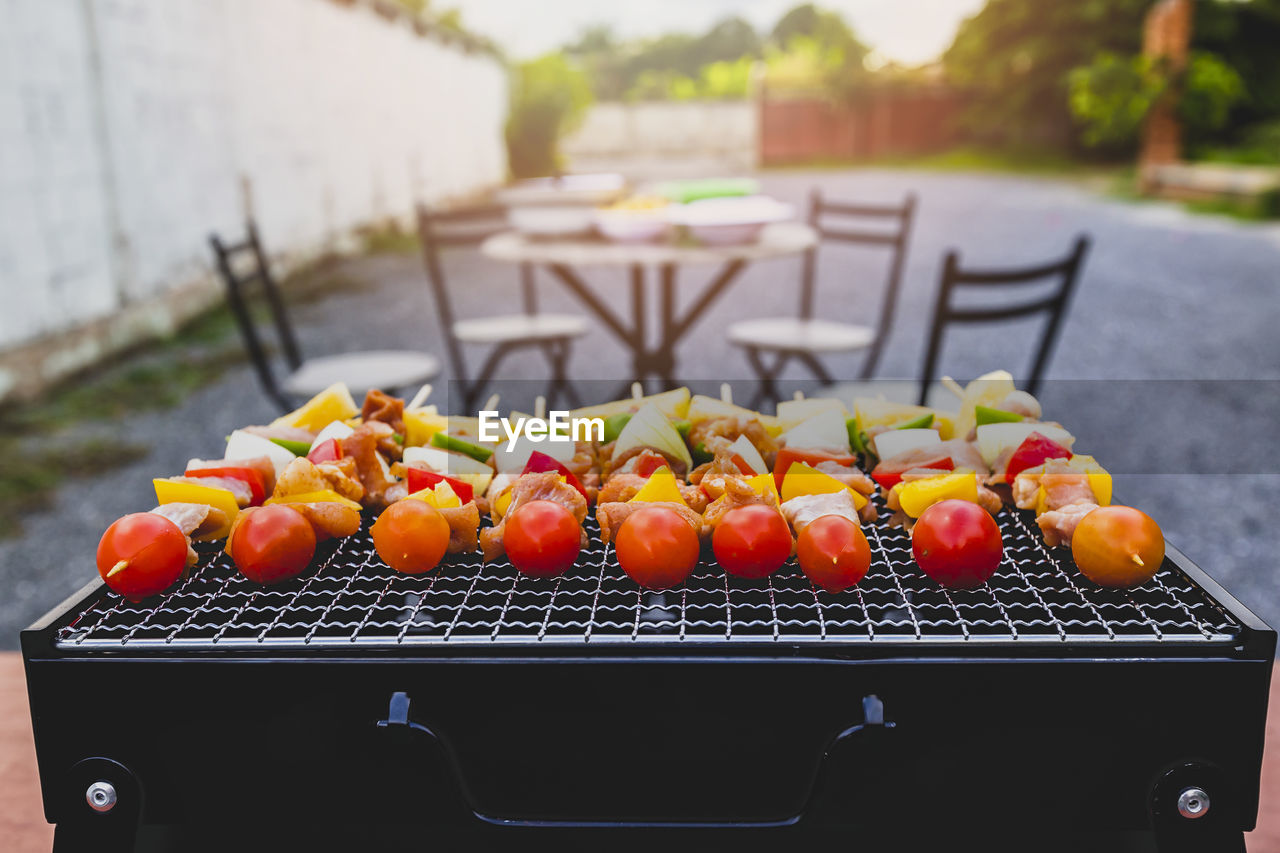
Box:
920 234 1091 406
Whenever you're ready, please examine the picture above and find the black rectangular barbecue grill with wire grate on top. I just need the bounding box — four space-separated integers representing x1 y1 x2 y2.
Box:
23 510 1275 852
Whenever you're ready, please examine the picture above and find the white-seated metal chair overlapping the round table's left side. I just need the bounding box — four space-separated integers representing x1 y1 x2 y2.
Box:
417 205 590 411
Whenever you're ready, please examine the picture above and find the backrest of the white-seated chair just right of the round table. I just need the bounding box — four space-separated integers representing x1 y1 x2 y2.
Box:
800 187 916 379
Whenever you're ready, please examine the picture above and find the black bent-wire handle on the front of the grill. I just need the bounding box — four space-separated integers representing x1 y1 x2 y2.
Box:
378 690 897 829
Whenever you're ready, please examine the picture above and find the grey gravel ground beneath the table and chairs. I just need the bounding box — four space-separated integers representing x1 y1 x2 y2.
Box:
0 170 1280 648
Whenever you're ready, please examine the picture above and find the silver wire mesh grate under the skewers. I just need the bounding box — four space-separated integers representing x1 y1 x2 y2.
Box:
58 510 1240 649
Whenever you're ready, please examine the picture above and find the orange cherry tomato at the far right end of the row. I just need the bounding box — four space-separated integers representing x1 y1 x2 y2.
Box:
1071 506 1165 587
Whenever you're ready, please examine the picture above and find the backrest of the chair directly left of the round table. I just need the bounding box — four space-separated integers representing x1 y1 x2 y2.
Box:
417 204 538 379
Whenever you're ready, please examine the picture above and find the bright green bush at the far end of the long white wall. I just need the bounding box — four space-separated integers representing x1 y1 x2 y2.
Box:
507 54 593 178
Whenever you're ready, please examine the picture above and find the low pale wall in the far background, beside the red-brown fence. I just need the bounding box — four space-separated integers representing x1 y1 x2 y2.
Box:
561 99 759 169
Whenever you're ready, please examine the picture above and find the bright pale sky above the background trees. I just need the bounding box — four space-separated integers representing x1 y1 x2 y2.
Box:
450 0 986 65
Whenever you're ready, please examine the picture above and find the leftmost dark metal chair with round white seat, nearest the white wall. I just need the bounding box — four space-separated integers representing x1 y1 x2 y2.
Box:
209 220 440 411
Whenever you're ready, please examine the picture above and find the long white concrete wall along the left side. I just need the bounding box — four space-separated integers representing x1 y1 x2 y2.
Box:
0 0 507 400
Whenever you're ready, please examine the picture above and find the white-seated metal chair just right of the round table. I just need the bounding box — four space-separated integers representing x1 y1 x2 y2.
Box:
728 190 916 407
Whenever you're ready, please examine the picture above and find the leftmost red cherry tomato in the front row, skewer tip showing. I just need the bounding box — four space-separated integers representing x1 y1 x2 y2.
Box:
97 512 187 599
